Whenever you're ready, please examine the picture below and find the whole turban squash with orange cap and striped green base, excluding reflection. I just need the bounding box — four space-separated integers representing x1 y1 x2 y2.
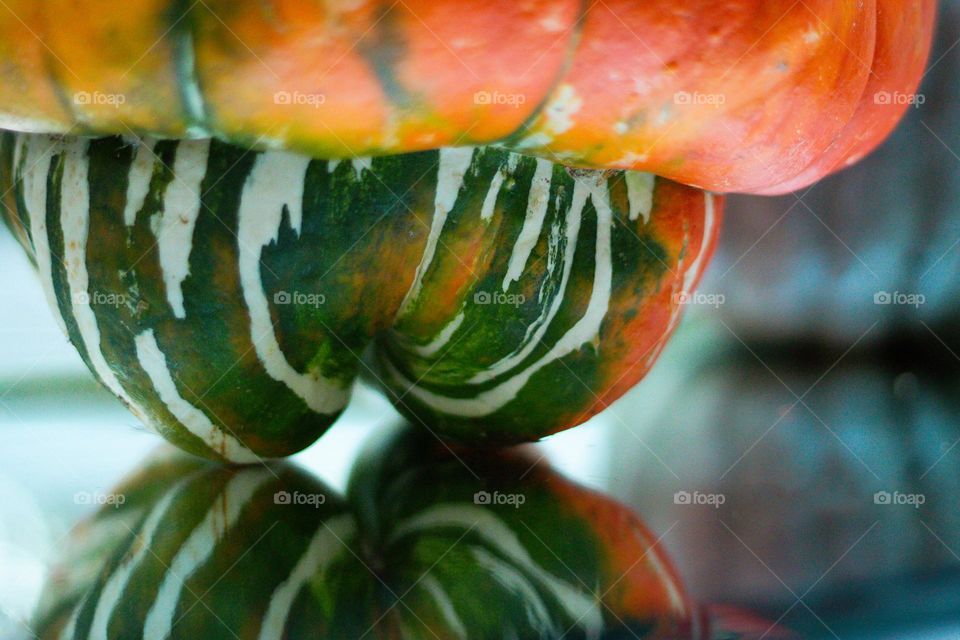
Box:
0 0 934 462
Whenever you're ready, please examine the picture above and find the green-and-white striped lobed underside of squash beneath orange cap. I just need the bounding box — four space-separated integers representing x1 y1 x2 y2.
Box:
0 134 721 462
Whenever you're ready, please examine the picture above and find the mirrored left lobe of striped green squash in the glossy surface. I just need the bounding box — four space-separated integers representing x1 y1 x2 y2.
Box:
36 459 360 640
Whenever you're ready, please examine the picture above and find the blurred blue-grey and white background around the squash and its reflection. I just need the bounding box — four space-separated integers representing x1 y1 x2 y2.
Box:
0 2 960 640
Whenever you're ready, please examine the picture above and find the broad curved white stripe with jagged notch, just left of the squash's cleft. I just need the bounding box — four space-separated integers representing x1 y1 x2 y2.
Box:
237 151 349 414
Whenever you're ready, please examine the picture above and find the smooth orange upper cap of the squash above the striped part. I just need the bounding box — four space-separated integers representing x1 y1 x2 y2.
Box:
0 0 935 193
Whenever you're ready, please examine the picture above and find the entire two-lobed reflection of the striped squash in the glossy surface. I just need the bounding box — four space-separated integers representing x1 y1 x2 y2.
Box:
35 424 700 640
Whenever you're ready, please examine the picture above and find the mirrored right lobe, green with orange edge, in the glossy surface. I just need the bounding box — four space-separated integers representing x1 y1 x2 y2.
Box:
348 428 693 638
